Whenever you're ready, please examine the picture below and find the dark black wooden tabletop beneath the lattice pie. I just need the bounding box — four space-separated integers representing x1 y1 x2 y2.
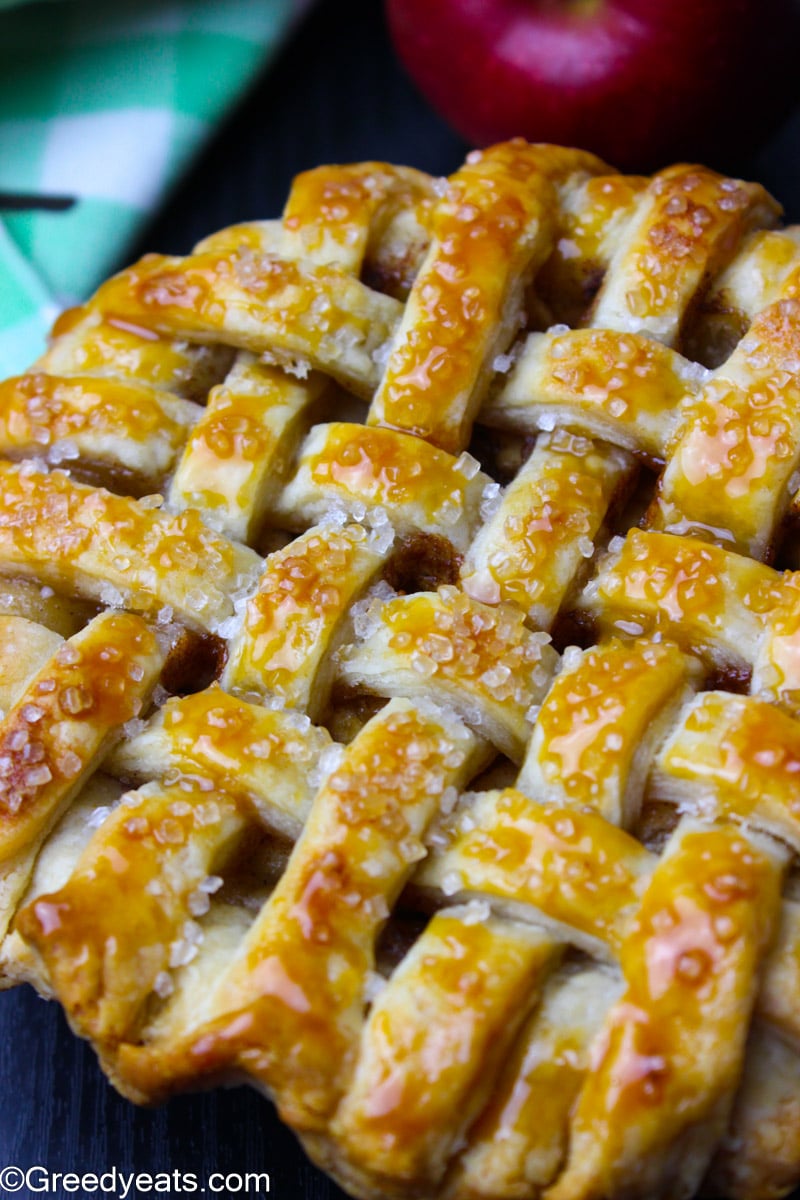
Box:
0 0 800 1200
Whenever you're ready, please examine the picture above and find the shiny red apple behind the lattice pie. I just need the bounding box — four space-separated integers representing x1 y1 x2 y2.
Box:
386 0 800 169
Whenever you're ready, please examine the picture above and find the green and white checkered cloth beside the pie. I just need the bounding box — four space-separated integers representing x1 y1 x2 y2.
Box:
0 0 305 378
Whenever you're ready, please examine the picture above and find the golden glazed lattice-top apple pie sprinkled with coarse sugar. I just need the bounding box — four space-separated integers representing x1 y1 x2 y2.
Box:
0 142 800 1200
